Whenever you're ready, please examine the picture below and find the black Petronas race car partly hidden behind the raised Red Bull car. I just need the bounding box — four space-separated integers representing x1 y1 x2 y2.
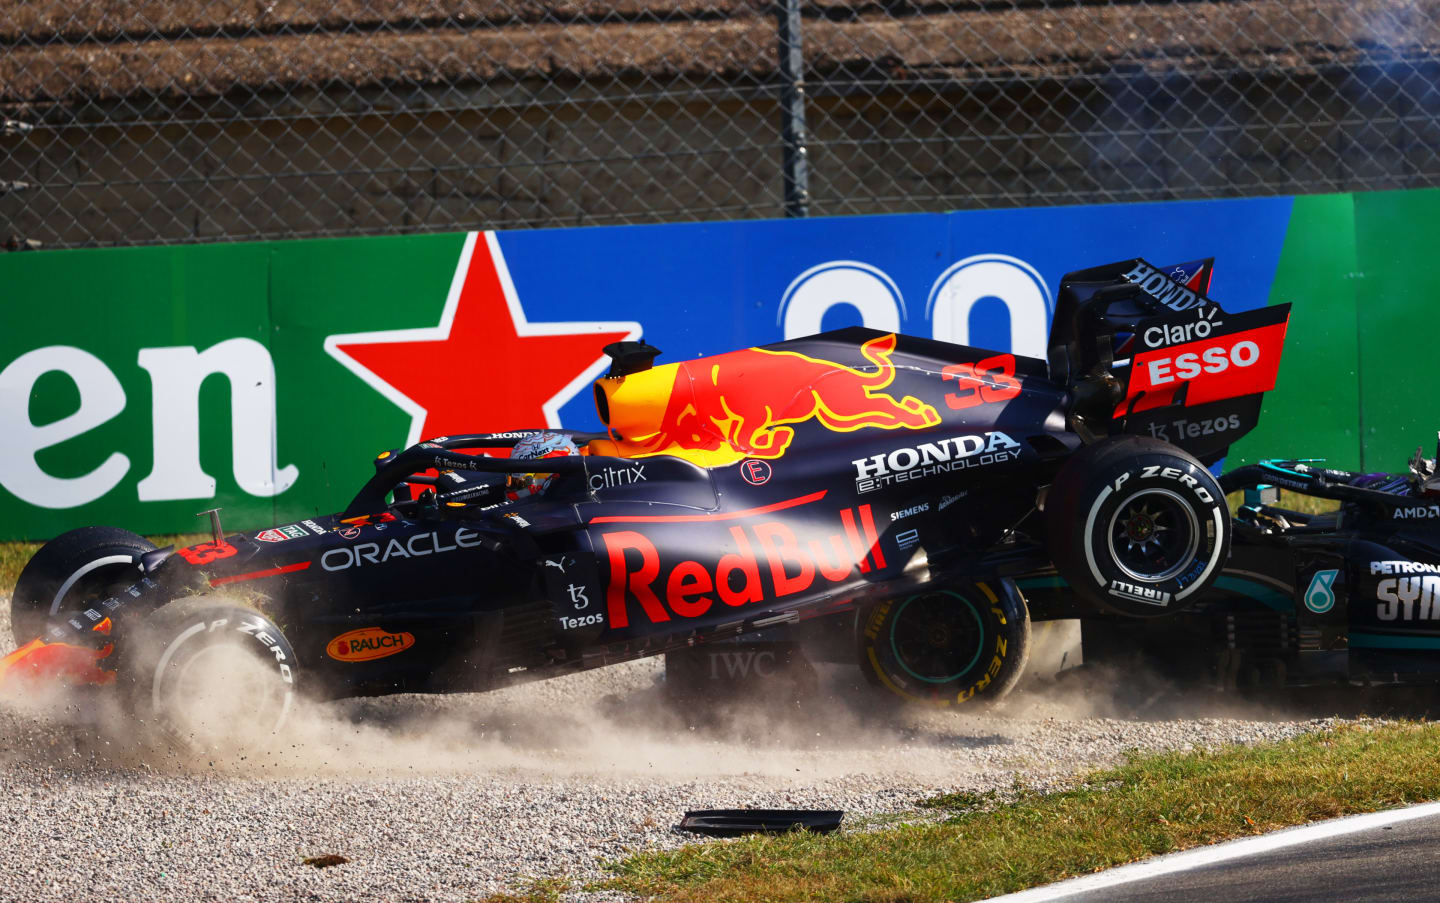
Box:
1054 440 1440 690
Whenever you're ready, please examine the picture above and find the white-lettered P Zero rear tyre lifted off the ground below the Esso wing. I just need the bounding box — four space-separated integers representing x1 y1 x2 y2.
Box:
1045 436 1230 618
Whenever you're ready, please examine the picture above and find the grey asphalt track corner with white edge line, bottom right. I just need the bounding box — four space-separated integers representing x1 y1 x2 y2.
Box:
998 804 1440 903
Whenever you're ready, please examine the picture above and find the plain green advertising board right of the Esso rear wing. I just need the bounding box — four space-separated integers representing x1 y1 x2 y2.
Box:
1230 189 1440 471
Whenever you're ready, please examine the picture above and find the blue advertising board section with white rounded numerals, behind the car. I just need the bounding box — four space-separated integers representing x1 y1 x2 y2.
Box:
497 197 1293 428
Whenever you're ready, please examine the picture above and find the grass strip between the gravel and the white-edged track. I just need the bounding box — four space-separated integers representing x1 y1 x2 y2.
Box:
598 722 1440 903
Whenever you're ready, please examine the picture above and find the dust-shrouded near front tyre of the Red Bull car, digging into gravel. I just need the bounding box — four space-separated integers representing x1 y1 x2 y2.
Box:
118 596 295 750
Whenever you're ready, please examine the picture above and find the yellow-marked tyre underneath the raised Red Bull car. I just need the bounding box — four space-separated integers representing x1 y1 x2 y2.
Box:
858 580 1030 707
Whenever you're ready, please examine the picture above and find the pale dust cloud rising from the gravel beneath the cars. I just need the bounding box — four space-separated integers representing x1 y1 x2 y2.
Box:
0 604 1393 781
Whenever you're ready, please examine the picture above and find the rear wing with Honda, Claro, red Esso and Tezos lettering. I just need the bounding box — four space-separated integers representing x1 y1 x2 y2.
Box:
1050 259 1290 464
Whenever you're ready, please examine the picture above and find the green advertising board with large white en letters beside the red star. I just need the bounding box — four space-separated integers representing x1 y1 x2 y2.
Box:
0 235 464 539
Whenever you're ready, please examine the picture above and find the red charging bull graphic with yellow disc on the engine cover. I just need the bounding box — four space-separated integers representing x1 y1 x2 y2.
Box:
596 334 940 467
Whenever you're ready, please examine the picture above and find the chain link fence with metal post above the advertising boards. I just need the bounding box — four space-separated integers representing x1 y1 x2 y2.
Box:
0 0 1440 248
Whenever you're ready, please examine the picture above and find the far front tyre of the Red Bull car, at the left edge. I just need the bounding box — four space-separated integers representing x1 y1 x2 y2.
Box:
10 527 156 645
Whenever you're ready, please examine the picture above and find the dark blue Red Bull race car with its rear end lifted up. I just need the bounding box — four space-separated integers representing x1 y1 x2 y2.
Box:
0 259 1289 733
